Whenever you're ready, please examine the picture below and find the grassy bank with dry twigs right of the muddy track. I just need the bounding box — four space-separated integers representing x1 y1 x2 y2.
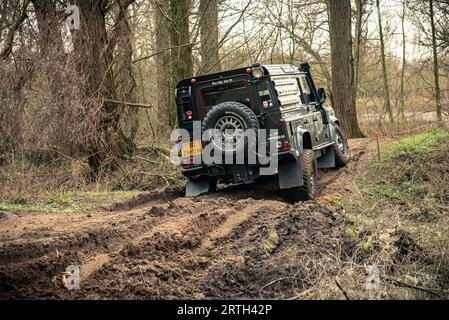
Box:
333 129 449 299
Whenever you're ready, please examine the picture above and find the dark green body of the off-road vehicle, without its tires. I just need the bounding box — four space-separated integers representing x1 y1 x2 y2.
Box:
175 63 349 196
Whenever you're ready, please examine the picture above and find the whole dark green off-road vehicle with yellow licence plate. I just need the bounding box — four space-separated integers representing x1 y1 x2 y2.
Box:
175 63 350 201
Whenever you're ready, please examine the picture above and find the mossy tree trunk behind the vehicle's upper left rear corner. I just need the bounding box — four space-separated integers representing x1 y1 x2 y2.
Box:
168 0 193 128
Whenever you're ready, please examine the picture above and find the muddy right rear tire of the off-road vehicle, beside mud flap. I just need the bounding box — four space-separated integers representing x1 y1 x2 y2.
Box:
290 149 318 202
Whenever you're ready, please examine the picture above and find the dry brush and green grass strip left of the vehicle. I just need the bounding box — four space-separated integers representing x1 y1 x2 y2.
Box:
0 146 184 212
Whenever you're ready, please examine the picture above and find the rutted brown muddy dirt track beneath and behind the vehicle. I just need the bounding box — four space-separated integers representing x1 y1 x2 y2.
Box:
0 139 375 299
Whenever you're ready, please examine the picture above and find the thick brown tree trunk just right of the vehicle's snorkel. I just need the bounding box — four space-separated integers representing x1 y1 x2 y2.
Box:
328 0 363 138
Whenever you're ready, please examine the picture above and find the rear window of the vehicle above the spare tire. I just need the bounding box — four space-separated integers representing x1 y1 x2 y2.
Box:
199 81 251 115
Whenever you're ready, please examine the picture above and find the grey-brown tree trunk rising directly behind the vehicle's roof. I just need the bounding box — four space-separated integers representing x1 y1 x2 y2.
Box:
198 0 221 73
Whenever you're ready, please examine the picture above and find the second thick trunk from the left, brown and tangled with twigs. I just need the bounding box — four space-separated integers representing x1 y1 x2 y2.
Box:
73 0 124 176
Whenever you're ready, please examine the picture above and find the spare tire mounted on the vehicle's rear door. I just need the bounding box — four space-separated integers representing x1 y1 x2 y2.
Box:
202 101 259 153
